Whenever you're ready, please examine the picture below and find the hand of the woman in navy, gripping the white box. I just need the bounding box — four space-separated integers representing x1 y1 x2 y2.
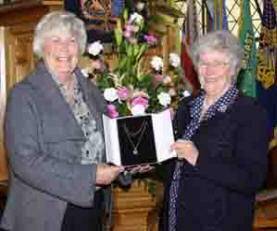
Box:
171 140 199 166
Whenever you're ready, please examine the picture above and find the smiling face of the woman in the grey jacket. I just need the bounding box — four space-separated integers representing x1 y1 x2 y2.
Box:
43 31 79 82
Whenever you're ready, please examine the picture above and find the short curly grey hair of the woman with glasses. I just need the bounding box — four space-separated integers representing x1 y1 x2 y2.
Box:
189 30 244 81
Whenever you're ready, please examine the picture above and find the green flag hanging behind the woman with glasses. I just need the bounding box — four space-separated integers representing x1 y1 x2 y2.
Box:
237 0 257 98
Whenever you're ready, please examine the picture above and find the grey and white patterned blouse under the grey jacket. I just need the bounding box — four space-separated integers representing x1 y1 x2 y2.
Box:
52 75 104 164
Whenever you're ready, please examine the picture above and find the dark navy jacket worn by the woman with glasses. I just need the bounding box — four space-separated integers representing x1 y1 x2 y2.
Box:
160 95 268 231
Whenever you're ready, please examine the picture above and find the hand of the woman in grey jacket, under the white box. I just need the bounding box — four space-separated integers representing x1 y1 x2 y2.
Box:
96 164 121 185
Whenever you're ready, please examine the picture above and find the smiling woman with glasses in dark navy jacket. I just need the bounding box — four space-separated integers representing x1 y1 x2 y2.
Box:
161 31 268 231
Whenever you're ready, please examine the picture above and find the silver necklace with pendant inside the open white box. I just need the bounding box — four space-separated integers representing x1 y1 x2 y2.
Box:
123 121 147 155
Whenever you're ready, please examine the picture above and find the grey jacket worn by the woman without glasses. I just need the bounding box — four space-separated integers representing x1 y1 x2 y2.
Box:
1 63 105 231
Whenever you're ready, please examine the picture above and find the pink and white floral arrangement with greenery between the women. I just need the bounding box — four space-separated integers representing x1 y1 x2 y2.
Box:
84 10 188 118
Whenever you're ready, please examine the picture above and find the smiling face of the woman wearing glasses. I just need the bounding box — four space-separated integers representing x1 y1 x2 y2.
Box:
198 50 235 96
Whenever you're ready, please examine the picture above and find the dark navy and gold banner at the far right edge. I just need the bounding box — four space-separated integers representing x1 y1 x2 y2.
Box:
254 0 277 141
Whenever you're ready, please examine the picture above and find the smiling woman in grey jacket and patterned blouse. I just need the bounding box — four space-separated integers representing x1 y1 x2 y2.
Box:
1 12 120 231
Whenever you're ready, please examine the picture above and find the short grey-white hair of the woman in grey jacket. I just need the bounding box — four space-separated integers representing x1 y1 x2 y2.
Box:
33 11 87 58
